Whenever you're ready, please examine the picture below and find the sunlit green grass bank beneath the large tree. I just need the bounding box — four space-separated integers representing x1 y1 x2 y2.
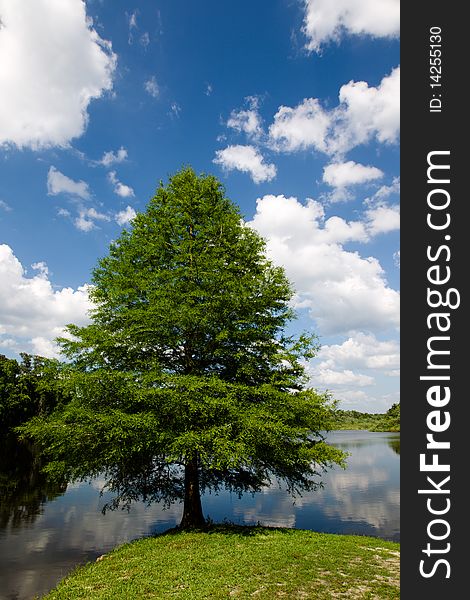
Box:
45 525 399 600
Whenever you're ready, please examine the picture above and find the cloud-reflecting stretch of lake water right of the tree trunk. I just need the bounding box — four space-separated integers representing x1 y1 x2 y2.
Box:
204 431 400 541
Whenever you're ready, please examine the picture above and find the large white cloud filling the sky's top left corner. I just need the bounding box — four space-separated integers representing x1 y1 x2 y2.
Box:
0 0 116 149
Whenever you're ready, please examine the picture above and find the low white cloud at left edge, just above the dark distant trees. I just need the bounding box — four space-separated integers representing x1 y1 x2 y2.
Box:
0 244 91 356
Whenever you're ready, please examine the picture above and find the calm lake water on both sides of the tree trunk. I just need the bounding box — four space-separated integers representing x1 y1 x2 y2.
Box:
0 431 400 600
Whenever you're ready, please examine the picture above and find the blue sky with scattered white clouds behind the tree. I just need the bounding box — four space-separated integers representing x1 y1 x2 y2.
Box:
0 0 400 412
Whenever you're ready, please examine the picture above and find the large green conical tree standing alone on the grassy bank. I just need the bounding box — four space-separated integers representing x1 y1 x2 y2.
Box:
22 168 343 527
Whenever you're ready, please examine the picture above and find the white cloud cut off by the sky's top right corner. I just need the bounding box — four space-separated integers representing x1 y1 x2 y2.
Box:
303 0 400 52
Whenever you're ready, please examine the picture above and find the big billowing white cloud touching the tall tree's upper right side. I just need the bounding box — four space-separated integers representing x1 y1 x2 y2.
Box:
249 196 399 334
